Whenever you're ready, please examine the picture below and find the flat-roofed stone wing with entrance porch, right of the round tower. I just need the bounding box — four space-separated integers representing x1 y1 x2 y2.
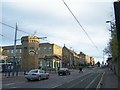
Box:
38 43 62 70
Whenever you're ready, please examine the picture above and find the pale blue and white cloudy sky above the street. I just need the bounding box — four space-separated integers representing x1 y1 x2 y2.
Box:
0 0 114 62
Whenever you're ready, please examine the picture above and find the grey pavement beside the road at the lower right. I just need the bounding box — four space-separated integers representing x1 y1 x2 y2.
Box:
98 68 120 90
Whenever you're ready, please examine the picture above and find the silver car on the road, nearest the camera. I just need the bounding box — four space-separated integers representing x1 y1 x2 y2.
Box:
25 69 50 81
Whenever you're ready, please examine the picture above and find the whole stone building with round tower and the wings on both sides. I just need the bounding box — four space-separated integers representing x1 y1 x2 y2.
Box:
1 36 62 71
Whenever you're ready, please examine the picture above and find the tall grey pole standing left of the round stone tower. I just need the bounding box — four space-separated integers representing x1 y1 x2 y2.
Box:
12 23 18 76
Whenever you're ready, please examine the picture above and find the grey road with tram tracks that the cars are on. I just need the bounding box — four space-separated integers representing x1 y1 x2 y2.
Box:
2 68 105 89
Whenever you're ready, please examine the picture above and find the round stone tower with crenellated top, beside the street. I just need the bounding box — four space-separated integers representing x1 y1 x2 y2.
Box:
21 36 40 71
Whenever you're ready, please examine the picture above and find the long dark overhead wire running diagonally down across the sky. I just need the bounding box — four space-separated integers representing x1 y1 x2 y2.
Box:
62 0 100 53
